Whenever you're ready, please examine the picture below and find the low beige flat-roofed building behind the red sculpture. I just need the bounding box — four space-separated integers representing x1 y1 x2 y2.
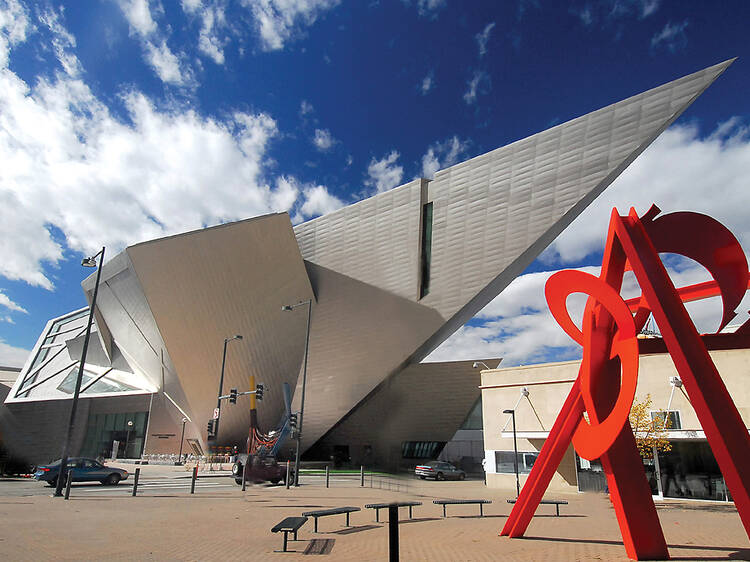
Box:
480 337 750 500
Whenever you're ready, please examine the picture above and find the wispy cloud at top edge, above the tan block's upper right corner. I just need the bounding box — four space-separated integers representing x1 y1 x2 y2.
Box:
244 0 340 51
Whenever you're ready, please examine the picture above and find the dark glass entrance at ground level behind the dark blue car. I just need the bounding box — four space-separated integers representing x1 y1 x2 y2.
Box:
81 412 148 459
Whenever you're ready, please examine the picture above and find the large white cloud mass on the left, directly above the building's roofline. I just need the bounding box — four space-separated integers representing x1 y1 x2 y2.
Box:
0 44 334 289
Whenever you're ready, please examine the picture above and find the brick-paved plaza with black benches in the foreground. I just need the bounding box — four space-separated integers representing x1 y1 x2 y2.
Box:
0 466 750 562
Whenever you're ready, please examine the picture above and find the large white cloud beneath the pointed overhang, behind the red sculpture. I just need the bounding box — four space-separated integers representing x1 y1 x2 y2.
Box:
428 118 750 366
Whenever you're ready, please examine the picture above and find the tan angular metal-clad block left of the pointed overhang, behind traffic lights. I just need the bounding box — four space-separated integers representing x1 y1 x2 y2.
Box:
127 214 313 445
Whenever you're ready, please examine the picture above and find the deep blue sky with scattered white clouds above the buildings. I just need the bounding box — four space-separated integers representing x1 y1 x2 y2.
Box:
0 0 750 365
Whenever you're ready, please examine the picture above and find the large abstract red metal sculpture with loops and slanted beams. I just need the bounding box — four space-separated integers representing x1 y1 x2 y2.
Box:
501 206 750 560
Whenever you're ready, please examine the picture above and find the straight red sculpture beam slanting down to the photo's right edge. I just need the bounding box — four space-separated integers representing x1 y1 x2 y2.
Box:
617 211 750 536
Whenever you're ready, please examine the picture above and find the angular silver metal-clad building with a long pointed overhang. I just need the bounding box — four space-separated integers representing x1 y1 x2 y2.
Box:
0 61 731 468
